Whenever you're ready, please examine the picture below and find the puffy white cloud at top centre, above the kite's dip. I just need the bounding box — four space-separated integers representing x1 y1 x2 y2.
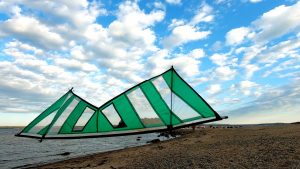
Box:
105 1 165 48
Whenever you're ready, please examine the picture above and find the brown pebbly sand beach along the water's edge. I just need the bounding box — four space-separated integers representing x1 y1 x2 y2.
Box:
34 124 300 169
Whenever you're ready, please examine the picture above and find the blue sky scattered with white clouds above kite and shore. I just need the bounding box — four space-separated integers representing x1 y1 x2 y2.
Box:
0 0 300 126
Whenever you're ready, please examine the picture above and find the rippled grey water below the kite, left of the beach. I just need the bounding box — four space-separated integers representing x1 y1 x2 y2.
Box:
0 128 167 169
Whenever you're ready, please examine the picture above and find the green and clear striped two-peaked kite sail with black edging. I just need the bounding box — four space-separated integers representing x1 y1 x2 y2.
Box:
16 67 223 139
